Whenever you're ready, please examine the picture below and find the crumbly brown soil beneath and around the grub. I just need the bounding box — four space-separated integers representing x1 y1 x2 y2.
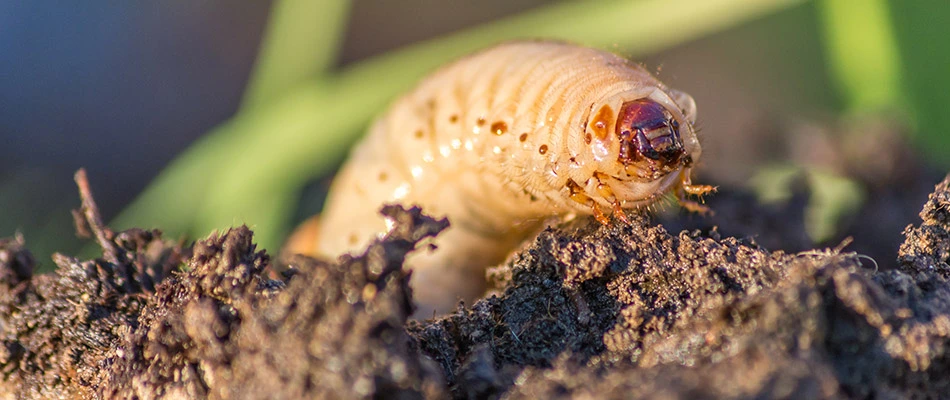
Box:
0 165 950 399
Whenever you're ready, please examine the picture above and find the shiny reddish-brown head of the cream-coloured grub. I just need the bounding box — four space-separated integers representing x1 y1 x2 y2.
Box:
585 88 701 205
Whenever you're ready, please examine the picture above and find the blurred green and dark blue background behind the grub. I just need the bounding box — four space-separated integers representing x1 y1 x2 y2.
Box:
0 0 950 265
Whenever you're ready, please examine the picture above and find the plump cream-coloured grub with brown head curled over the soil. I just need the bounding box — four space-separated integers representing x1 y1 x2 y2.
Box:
308 41 712 315
